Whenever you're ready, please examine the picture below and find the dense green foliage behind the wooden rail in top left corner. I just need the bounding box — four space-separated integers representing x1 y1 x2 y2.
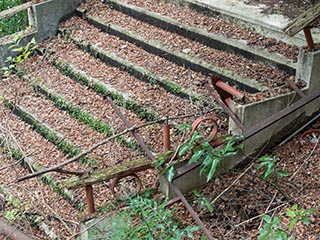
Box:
0 0 28 38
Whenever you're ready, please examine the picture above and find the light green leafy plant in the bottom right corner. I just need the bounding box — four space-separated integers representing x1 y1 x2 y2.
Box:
259 204 315 240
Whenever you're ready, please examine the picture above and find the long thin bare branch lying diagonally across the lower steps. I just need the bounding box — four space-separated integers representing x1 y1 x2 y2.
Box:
16 114 198 182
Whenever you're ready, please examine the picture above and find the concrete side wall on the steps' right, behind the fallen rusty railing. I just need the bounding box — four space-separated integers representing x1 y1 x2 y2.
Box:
160 93 320 198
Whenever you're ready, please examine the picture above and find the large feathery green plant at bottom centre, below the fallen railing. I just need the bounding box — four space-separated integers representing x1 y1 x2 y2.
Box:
90 196 199 240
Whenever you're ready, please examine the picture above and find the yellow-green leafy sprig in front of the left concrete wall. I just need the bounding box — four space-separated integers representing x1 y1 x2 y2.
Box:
0 35 38 77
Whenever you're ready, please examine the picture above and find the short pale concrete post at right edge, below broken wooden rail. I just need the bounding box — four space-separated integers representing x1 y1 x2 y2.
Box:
296 48 320 92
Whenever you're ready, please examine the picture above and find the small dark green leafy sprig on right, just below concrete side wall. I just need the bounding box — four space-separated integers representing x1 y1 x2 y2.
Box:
257 155 289 182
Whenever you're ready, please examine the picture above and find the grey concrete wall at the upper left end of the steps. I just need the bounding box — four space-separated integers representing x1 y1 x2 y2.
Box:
0 0 82 70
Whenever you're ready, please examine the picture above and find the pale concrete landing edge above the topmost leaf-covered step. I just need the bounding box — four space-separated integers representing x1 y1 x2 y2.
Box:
170 0 320 47
